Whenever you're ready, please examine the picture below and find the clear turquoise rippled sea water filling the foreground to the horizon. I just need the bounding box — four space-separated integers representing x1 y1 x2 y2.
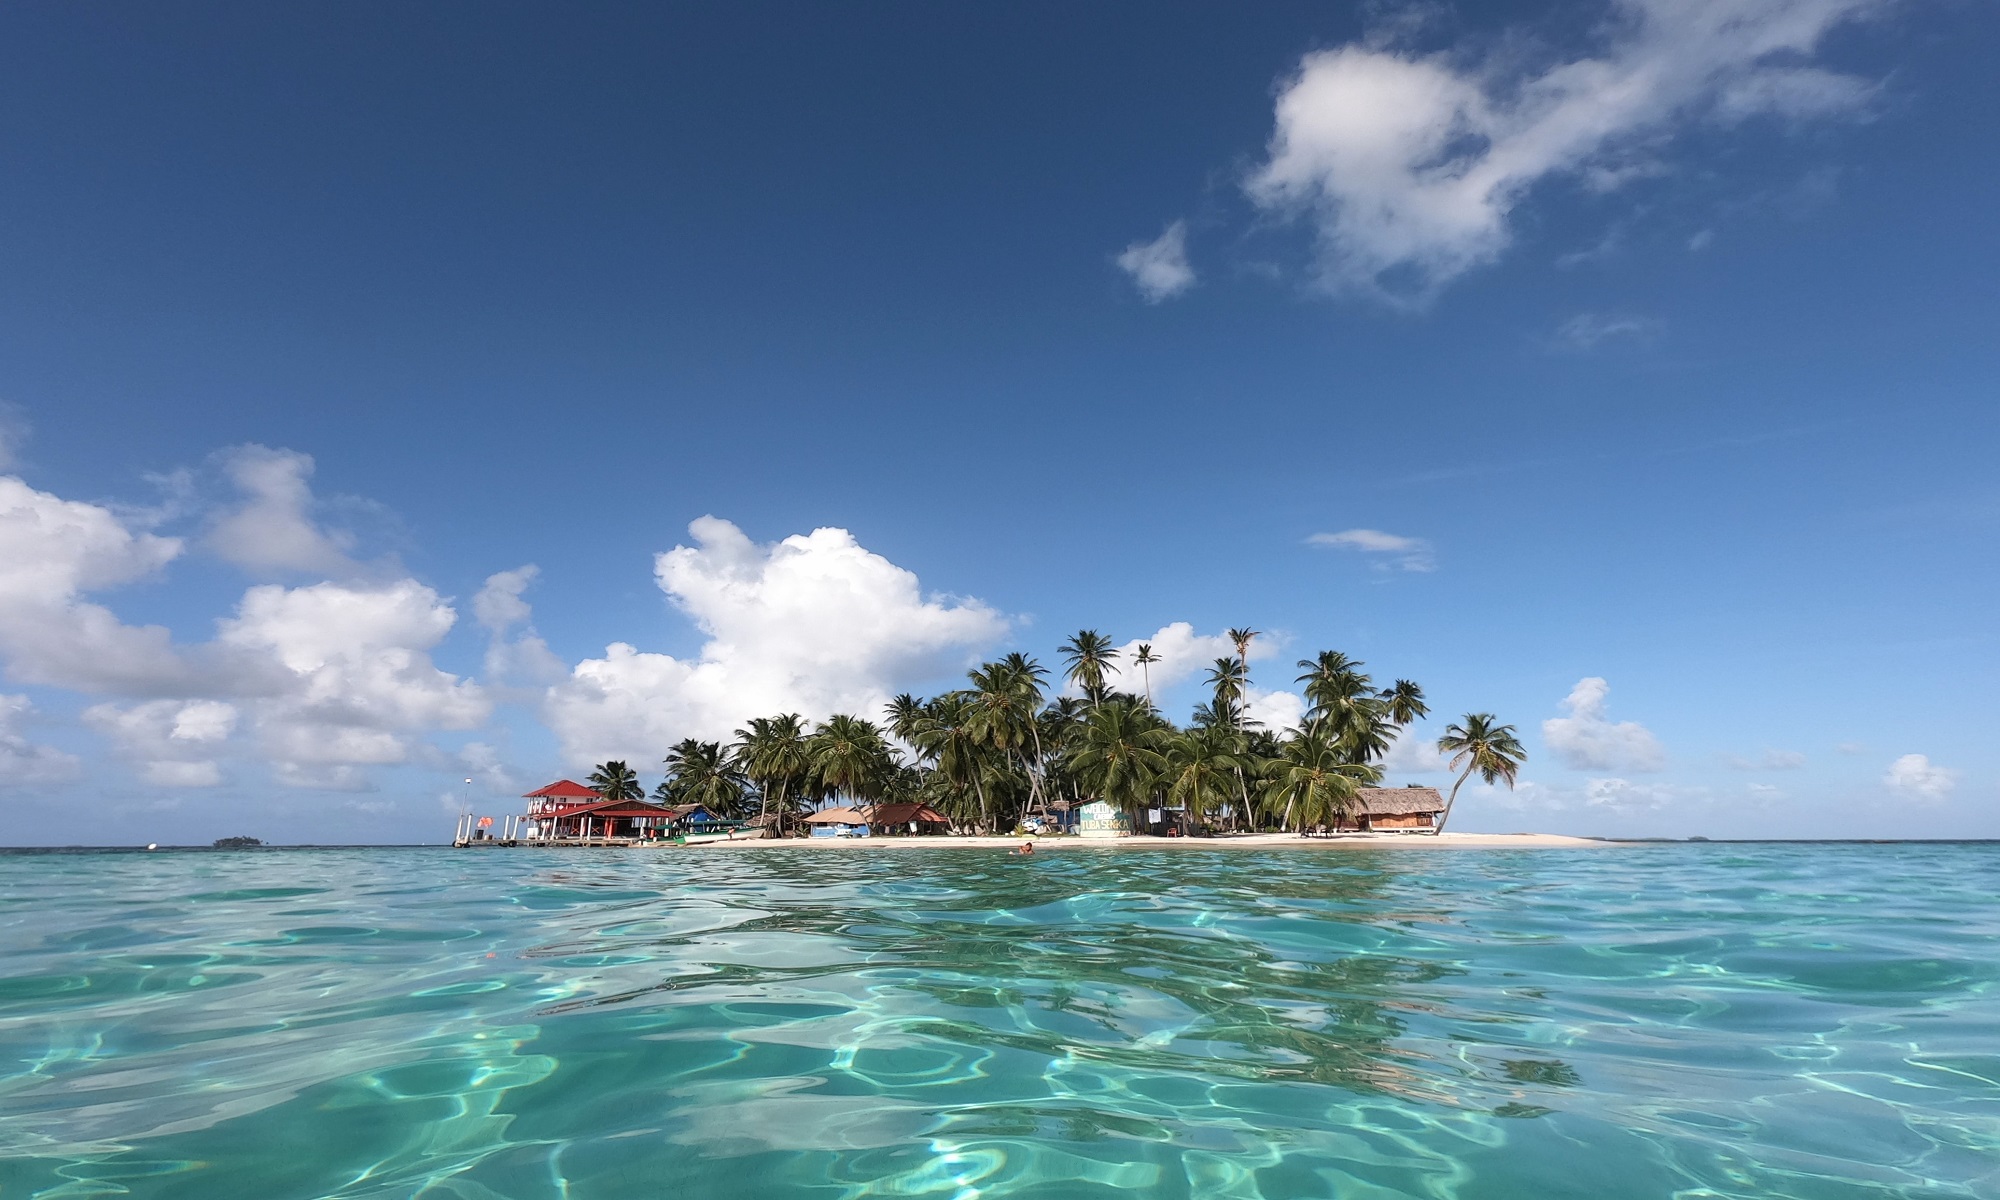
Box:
0 844 2000 1200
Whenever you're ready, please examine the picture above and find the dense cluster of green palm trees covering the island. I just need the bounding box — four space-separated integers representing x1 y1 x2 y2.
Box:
590 628 1526 832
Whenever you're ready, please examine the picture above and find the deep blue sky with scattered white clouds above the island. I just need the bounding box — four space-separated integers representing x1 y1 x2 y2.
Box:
0 0 2000 844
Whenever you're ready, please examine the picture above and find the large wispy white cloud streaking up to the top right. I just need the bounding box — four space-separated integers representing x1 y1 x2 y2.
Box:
1246 0 1886 302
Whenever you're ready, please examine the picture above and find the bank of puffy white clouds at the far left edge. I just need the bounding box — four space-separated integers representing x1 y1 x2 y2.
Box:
0 460 508 788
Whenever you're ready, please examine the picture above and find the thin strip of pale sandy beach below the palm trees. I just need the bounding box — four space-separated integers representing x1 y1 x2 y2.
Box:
692 832 1622 854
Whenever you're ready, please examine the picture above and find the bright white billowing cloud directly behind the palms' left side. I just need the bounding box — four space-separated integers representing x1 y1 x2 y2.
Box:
544 516 1008 764
